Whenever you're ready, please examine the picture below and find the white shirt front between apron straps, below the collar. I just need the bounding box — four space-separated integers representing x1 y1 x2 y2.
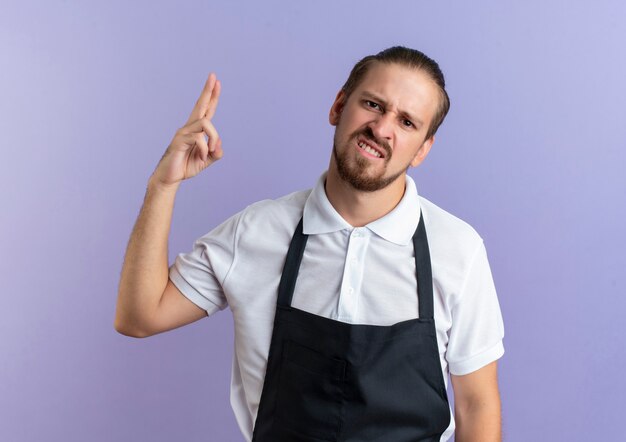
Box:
292 229 418 325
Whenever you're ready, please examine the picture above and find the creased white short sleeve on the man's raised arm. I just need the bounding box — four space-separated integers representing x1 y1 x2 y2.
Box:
169 213 242 315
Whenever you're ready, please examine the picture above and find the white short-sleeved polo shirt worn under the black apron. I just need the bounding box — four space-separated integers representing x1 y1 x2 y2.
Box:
169 174 504 441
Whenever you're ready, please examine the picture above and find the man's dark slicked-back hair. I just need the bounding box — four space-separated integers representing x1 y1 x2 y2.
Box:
341 46 450 139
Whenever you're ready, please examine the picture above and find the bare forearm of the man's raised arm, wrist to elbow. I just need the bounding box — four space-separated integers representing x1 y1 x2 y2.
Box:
115 178 179 334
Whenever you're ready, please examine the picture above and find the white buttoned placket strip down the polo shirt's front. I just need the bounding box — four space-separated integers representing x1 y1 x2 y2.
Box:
336 227 370 323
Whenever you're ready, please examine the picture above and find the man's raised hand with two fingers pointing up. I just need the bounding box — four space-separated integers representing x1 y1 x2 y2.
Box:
151 73 223 186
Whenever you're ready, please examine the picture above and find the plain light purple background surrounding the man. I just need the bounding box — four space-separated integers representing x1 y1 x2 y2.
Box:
0 0 626 442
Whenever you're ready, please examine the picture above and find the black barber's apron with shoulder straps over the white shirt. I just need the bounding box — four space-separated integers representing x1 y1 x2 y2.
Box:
252 215 450 442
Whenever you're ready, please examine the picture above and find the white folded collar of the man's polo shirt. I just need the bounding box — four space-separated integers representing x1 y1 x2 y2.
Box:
303 172 420 245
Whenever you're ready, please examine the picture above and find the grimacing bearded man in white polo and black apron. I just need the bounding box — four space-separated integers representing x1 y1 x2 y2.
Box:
115 47 504 442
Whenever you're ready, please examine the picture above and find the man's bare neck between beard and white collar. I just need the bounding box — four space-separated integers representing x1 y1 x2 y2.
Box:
325 164 406 227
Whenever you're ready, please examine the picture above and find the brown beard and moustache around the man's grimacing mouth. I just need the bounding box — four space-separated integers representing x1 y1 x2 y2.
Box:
333 127 408 192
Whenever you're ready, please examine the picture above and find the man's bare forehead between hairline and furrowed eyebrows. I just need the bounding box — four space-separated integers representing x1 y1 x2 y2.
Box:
352 62 439 124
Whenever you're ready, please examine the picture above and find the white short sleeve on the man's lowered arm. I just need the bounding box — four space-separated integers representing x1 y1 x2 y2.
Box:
446 241 504 375
